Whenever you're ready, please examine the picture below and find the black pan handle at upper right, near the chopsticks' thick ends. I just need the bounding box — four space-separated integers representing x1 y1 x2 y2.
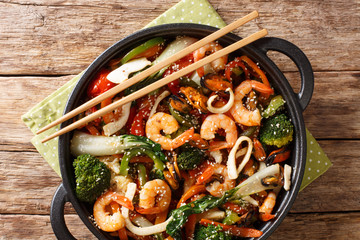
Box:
255 37 314 111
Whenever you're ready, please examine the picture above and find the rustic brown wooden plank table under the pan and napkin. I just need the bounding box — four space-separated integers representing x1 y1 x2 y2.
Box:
0 0 360 239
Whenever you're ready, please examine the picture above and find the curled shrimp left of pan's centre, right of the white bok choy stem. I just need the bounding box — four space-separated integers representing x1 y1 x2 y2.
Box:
145 112 194 150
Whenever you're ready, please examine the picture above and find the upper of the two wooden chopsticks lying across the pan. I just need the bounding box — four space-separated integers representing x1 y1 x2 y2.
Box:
36 11 259 134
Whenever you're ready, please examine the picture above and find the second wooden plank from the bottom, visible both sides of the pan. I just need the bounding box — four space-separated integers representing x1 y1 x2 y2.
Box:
0 141 360 214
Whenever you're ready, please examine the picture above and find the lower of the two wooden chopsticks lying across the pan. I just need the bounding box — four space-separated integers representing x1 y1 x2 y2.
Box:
41 29 267 143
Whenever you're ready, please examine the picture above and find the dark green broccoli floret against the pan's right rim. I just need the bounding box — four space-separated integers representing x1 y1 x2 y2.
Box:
260 114 294 148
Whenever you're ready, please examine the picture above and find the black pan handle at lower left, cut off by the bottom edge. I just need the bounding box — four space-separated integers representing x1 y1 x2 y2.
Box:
50 184 76 240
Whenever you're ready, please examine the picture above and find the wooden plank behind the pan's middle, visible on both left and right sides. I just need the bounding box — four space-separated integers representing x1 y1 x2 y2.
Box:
0 72 360 148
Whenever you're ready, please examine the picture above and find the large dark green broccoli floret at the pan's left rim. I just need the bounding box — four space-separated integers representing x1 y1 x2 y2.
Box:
73 154 111 203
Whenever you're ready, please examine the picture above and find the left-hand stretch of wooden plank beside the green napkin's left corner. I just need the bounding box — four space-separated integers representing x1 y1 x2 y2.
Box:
0 76 74 147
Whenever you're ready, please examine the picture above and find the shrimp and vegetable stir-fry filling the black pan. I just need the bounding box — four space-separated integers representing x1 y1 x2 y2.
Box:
71 36 294 240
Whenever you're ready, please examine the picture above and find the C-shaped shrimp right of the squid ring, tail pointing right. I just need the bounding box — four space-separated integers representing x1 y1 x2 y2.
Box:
230 80 274 126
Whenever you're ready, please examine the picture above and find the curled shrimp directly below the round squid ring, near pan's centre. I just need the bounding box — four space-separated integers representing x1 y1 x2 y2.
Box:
200 113 237 151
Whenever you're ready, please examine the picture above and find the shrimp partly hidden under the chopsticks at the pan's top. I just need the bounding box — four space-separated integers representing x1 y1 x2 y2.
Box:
193 42 228 77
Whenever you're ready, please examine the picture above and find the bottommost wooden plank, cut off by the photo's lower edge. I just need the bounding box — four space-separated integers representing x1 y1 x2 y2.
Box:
0 213 360 240
